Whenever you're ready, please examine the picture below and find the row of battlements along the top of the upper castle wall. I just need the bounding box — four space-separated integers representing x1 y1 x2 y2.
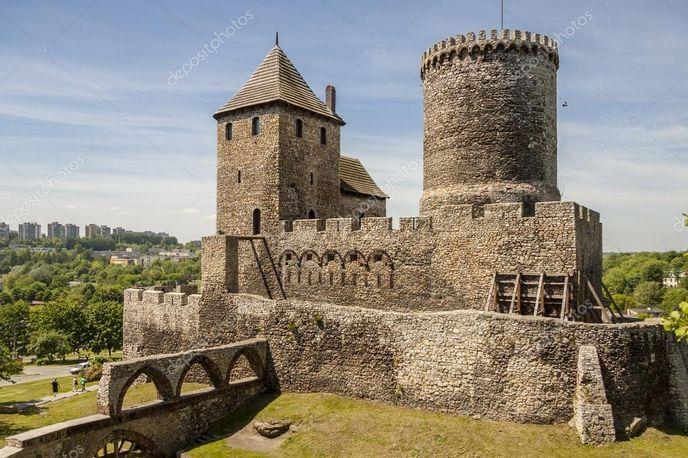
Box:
280 201 600 234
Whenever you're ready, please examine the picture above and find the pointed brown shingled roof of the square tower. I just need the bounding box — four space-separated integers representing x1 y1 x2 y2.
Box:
215 44 344 124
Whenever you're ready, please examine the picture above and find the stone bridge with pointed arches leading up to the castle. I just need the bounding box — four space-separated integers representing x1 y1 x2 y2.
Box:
0 339 268 457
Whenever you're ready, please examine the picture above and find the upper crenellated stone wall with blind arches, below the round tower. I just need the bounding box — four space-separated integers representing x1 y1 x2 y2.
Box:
224 202 602 311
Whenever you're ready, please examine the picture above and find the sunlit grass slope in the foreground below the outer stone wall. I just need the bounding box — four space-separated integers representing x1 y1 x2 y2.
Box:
188 393 688 458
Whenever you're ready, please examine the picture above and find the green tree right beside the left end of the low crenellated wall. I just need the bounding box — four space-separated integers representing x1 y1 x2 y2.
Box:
86 301 123 355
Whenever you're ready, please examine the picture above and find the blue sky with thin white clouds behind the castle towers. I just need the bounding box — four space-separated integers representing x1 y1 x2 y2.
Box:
0 0 688 251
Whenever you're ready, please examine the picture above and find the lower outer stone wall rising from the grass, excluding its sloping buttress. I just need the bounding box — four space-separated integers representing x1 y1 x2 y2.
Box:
230 298 675 430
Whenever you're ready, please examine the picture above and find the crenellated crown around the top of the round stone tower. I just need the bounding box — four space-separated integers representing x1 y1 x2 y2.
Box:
421 29 559 78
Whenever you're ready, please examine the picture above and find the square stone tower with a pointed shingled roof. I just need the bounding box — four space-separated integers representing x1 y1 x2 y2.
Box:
214 45 344 235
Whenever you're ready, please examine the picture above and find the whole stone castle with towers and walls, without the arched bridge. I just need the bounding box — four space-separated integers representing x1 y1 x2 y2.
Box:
119 30 688 443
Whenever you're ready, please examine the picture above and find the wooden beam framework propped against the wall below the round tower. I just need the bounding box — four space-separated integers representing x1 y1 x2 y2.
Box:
485 271 623 323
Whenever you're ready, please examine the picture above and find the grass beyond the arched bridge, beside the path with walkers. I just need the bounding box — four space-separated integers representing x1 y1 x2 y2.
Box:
0 377 205 448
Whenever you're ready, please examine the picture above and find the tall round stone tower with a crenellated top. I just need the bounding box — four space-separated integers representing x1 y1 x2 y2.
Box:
421 30 560 215
